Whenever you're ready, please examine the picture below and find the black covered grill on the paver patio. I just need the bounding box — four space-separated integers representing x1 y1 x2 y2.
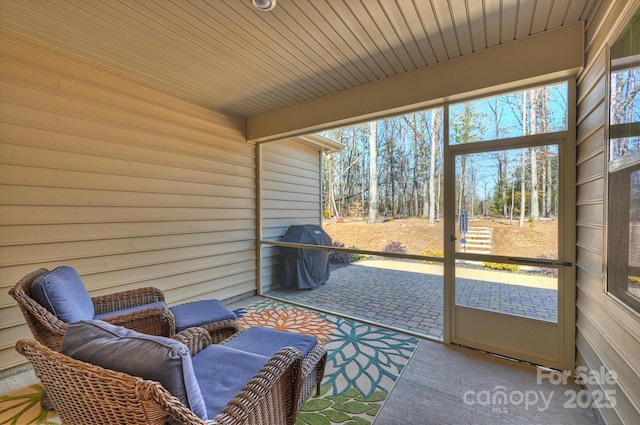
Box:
280 224 332 289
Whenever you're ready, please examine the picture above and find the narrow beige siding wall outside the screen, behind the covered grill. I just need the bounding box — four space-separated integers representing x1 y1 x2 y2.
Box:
261 140 322 292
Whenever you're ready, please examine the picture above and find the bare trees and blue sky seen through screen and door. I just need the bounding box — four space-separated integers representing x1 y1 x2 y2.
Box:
322 83 567 226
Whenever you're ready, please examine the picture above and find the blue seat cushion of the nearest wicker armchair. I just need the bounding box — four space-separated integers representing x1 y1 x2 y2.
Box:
192 344 269 418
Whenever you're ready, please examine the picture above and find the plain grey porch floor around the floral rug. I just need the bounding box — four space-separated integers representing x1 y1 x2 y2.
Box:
0 291 603 425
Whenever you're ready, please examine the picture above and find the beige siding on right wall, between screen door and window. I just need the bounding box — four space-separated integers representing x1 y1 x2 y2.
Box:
576 0 640 424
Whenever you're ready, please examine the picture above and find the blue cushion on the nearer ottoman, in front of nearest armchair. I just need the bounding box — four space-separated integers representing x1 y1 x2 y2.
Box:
224 326 318 358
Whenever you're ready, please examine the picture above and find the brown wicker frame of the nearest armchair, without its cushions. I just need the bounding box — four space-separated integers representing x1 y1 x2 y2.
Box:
16 328 300 425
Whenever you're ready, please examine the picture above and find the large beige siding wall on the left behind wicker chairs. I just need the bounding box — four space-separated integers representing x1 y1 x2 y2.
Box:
0 31 256 369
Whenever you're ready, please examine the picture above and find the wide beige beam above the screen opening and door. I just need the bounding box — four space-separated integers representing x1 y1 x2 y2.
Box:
247 22 584 142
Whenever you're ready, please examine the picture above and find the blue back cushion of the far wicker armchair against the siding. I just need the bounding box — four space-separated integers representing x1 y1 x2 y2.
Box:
31 266 95 323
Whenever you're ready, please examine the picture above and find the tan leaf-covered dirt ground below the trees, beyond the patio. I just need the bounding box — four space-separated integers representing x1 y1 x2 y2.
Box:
323 218 558 258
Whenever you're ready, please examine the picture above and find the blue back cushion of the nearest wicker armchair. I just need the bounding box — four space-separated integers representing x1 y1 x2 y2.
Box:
62 320 208 420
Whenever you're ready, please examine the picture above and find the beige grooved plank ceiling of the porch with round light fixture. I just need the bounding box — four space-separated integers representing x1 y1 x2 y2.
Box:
0 0 603 117
